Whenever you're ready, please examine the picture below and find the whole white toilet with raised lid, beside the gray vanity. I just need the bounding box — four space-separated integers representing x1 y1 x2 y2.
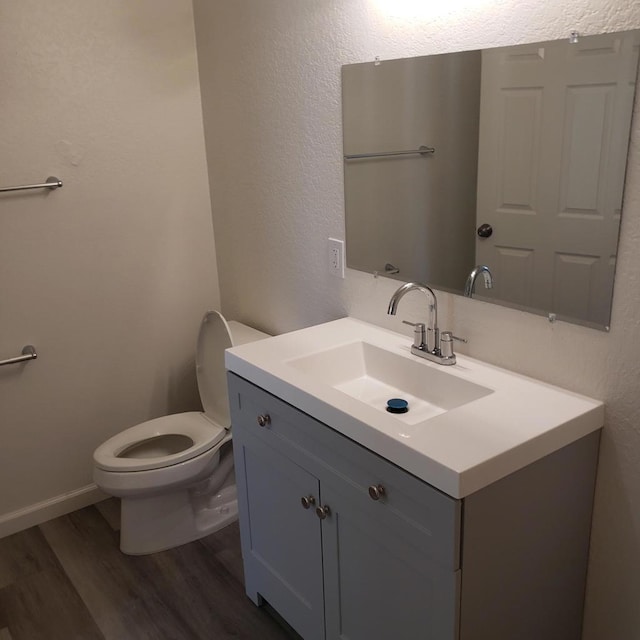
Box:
93 311 268 555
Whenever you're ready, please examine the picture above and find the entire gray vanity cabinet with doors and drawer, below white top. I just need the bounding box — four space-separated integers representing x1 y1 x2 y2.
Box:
229 373 598 640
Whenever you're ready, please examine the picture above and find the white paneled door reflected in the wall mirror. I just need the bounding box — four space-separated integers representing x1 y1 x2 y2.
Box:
476 33 639 326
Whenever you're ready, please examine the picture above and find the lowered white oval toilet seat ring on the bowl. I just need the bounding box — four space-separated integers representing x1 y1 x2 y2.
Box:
93 411 227 471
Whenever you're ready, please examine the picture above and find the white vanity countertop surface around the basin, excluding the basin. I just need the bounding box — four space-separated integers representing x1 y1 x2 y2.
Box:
225 318 604 498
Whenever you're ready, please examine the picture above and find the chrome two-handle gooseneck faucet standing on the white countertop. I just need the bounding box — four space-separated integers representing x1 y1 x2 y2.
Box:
387 282 456 365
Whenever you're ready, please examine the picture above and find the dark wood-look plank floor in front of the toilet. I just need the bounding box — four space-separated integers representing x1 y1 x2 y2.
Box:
0 499 299 640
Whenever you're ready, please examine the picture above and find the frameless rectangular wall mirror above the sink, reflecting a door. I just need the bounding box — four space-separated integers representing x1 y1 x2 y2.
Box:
342 31 640 329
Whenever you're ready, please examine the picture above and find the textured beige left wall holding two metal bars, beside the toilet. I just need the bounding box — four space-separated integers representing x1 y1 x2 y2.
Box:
0 0 219 533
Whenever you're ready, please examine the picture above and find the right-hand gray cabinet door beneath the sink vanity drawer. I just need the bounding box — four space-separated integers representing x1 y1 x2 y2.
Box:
322 484 460 640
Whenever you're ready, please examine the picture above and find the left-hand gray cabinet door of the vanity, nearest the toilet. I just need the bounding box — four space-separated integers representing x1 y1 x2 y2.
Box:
234 438 325 640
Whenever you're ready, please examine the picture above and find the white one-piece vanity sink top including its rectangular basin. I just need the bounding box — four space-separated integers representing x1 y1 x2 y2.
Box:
225 318 604 498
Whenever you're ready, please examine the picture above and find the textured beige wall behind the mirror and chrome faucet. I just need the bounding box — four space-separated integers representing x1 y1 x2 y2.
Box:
194 0 640 640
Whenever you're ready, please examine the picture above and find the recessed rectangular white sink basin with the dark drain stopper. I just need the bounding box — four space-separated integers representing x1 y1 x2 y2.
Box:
287 341 492 424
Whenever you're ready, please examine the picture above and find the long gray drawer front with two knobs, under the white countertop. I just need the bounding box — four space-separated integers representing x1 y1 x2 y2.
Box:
229 374 461 570
